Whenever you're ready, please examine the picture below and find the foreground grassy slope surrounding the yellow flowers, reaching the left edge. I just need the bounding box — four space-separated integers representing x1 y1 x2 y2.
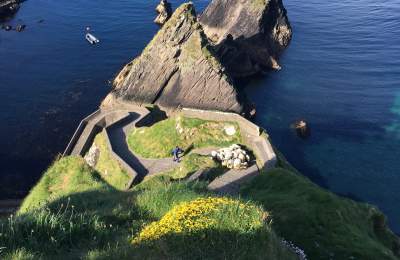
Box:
0 157 292 259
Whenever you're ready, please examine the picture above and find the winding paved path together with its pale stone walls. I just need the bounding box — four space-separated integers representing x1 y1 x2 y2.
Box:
64 103 277 191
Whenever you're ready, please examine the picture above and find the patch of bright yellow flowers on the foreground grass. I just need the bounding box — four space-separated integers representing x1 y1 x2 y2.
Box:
133 197 263 244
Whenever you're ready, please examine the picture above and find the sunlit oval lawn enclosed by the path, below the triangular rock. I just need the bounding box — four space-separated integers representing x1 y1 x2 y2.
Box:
127 116 241 158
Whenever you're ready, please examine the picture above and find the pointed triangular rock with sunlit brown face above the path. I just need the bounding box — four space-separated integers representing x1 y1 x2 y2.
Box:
103 3 244 113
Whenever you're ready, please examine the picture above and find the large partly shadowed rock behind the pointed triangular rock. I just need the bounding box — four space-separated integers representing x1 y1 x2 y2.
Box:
200 0 292 77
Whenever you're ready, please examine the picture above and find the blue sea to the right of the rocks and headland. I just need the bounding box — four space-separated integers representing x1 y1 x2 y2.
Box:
249 0 400 232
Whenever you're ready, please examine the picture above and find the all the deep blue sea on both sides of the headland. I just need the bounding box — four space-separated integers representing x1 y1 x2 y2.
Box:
0 0 400 232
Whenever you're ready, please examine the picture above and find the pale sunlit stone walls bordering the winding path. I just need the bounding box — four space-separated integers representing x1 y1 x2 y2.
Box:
63 105 277 188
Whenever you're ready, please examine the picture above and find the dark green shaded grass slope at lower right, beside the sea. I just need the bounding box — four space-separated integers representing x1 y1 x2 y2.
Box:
241 168 398 260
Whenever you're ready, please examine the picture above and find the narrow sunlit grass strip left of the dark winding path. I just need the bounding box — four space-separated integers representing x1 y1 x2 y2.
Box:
94 132 131 190
